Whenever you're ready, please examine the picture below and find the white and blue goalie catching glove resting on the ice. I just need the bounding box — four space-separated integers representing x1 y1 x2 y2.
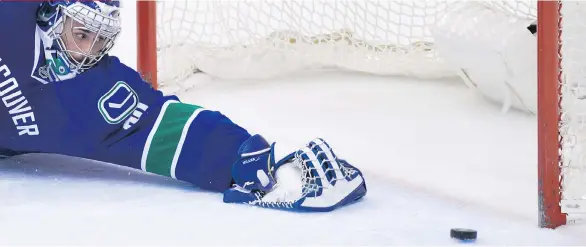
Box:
224 135 366 211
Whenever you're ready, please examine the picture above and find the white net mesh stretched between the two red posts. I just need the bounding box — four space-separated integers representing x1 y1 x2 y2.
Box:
157 0 536 89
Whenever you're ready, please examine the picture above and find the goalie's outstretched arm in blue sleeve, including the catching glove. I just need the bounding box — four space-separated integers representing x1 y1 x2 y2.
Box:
52 58 366 211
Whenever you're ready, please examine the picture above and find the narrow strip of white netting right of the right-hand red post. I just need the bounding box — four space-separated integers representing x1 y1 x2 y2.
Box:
560 1 586 213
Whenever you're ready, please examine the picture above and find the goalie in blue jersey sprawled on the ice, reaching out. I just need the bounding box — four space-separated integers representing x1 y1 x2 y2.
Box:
0 0 366 211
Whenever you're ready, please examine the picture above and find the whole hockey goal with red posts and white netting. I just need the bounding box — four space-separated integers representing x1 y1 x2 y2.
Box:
138 0 586 227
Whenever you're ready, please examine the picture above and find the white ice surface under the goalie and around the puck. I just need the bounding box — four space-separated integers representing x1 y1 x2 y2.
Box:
0 73 586 246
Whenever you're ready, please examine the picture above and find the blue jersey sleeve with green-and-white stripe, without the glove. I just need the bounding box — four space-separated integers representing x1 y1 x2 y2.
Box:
57 57 250 191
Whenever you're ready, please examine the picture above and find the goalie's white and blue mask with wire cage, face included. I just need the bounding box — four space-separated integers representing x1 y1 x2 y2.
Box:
37 0 121 74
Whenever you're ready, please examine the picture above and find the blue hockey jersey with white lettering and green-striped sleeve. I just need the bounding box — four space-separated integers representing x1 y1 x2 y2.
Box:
0 1 250 191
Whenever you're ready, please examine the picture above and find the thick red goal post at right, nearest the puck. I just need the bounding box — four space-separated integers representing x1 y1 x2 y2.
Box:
536 1 566 228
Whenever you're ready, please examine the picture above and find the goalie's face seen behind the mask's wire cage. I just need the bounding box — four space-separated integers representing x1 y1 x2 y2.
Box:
61 18 108 63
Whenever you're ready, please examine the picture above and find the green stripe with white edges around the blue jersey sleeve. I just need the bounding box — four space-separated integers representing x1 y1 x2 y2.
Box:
141 102 203 179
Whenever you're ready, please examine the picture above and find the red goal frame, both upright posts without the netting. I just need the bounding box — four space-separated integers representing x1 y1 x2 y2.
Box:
137 0 580 228
